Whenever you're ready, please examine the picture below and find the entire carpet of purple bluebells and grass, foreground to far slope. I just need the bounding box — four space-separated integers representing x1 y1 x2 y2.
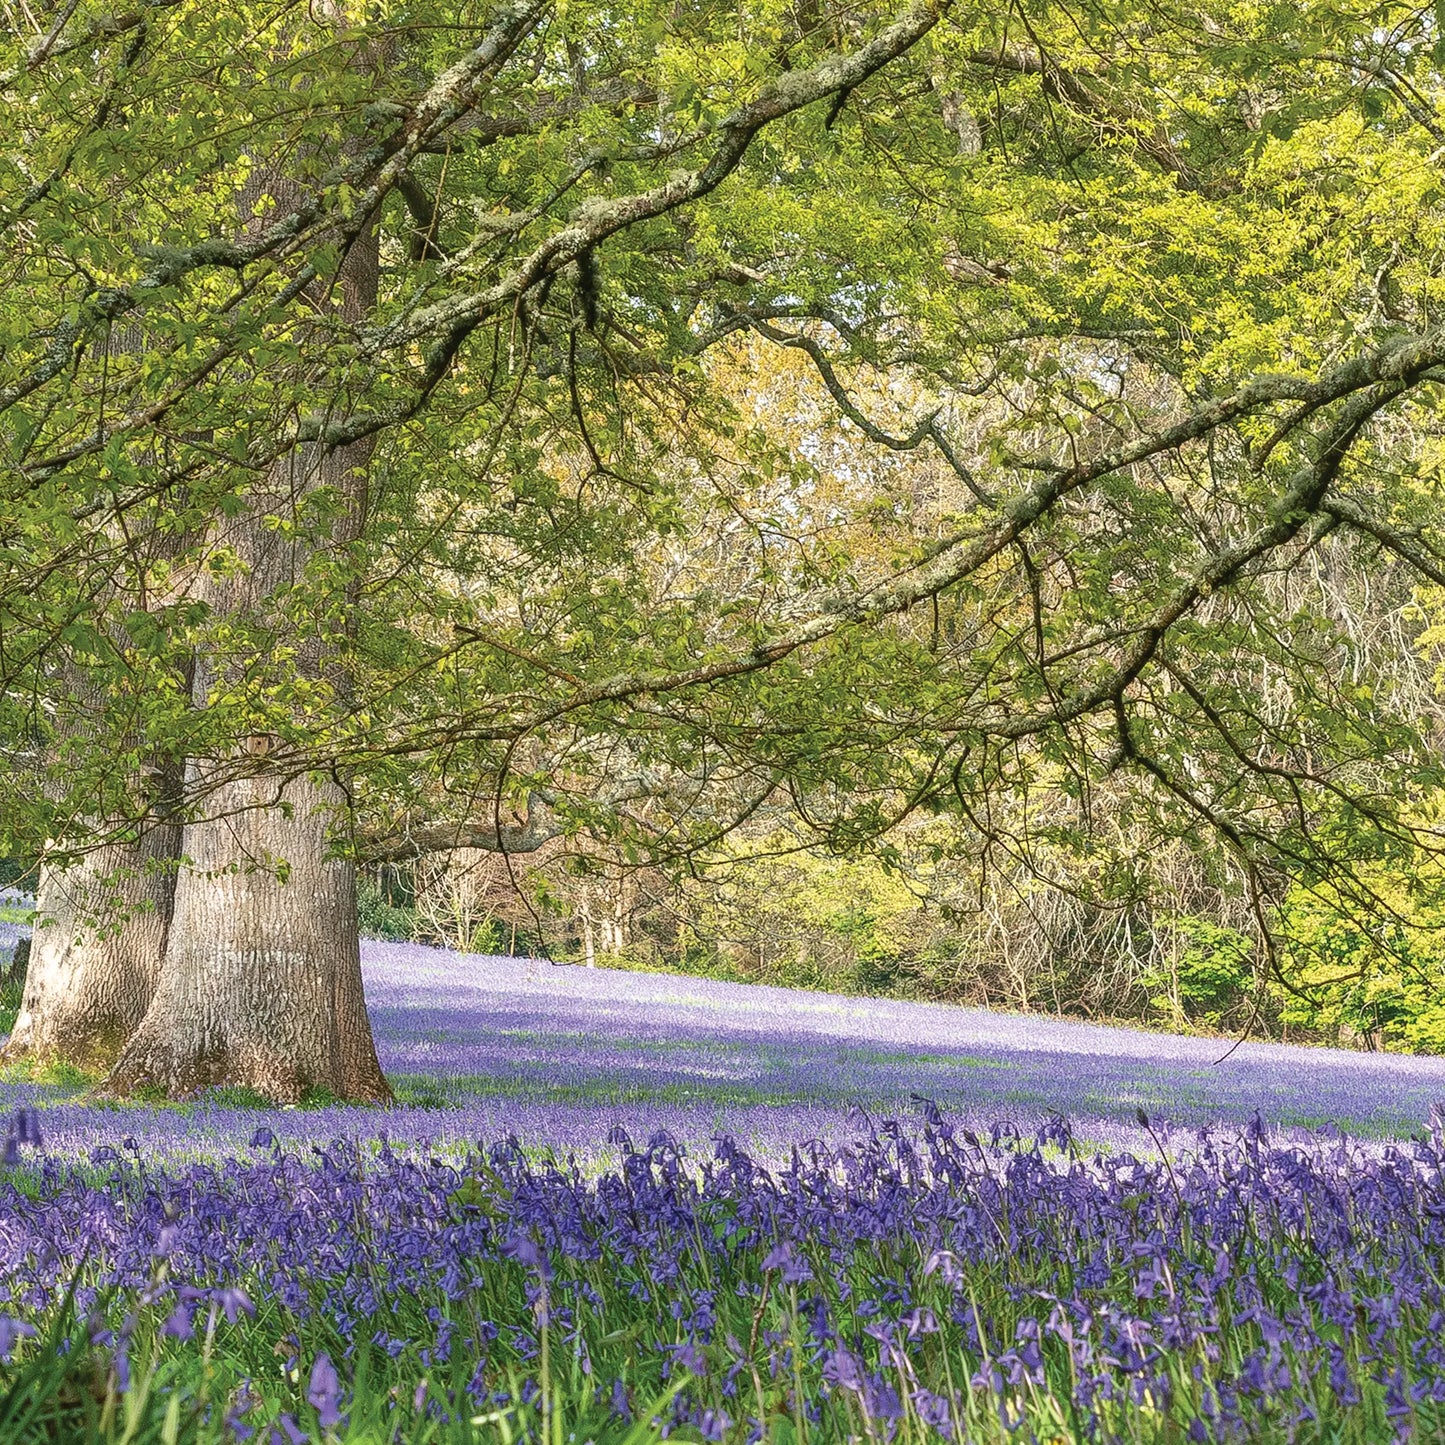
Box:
0 931 1445 1445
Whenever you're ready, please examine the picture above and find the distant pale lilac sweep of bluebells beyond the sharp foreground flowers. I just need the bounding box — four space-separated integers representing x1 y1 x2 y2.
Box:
8 942 1445 1162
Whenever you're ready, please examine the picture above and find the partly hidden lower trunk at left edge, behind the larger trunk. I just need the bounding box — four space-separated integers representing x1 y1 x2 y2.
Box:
4 824 181 1069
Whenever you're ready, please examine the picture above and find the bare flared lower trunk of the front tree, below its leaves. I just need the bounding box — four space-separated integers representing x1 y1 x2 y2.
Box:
107 777 390 1103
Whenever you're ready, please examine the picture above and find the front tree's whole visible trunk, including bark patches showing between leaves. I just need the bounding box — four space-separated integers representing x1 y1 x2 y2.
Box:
105 115 392 1103
